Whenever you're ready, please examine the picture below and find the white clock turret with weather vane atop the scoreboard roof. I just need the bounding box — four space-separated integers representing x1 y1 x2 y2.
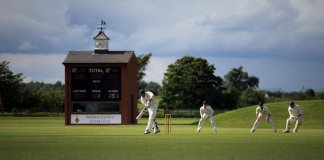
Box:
93 20 110 54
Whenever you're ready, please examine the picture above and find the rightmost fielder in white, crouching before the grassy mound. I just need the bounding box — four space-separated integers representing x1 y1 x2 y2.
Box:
283 102 304 133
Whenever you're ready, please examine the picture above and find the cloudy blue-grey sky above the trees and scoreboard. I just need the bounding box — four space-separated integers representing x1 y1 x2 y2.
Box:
0 0 324 91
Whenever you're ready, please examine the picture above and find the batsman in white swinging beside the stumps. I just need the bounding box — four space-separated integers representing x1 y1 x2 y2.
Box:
140 90 160 134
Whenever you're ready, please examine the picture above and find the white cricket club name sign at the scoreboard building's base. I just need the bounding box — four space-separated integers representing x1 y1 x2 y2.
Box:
71 114 121 124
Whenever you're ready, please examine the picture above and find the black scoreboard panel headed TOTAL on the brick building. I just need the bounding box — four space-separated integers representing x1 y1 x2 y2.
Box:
71 67 121 101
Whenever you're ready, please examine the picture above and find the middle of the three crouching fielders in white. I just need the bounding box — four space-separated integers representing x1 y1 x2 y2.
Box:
251 102 277 132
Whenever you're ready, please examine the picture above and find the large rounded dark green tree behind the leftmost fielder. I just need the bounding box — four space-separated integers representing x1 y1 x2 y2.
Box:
159 56 223 108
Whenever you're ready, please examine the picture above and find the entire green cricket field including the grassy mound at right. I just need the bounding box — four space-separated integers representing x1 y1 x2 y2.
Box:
0 101 324 160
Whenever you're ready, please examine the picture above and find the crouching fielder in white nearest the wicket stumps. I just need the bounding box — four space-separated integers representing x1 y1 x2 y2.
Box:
197 101 217 133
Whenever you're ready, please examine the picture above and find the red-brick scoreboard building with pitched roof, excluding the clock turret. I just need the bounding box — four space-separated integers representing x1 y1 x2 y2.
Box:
63 51 138 125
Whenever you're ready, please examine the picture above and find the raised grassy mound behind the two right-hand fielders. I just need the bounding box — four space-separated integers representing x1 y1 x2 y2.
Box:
215 100 324 129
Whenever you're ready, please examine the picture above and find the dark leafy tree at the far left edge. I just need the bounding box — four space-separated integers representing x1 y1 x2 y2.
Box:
0 61 23 108
